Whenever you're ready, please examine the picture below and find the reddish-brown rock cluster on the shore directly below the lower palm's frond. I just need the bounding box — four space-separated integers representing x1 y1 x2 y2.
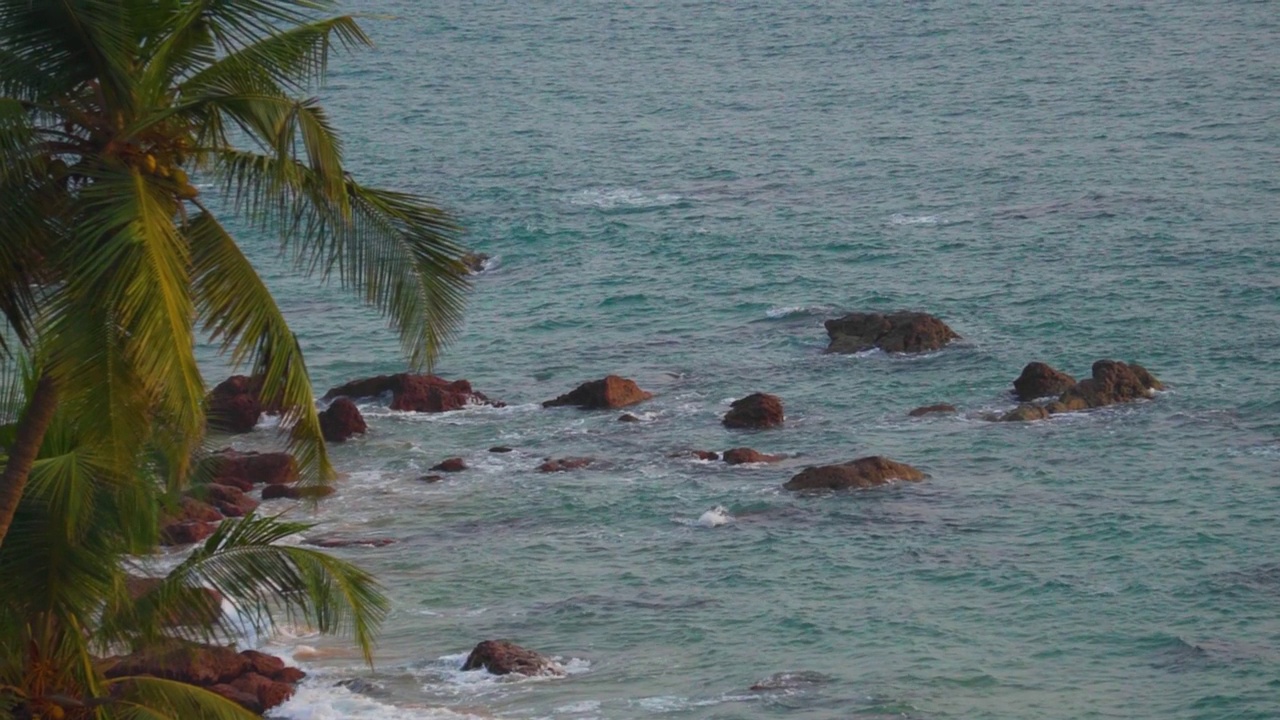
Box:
102 641 306 714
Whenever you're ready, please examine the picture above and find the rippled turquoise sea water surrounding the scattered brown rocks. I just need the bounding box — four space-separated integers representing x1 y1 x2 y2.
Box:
225 0 1280 720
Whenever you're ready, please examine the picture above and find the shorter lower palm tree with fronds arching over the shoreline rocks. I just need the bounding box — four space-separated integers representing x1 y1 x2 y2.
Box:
0 363 387 719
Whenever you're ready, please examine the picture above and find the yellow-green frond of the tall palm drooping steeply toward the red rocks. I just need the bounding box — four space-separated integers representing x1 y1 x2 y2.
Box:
186 210 333 482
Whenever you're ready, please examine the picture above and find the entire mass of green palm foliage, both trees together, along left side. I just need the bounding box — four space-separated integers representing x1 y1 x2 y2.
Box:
0 0 466 717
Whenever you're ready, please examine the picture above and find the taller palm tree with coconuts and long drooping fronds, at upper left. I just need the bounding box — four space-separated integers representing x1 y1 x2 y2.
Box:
0 0 466 547
